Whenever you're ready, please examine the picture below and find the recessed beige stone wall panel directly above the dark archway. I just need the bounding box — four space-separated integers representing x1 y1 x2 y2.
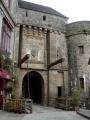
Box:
21 25 46 69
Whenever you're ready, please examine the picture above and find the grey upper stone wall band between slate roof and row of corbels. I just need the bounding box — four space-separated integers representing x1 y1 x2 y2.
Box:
17 8 67 31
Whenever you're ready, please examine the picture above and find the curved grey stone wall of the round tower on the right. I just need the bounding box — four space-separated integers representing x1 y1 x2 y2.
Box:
67 21 90 97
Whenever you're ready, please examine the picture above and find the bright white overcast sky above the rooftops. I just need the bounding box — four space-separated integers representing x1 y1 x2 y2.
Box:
22 0 90 23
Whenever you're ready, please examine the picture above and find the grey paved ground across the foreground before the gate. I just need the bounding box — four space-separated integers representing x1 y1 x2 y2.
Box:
0 105 87 120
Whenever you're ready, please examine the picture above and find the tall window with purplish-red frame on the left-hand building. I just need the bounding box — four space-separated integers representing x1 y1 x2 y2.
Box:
1 19 11 53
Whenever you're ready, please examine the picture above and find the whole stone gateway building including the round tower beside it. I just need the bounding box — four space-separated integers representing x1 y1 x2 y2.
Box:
14 0 90 105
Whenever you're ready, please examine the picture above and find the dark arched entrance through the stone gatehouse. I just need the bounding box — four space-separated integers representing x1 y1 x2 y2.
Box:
22 71 44 104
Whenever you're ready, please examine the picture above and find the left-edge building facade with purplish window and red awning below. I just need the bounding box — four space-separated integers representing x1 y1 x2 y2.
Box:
0 0 15 109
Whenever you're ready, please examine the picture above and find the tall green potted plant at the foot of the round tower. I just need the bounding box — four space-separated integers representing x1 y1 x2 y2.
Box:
72 86 80 111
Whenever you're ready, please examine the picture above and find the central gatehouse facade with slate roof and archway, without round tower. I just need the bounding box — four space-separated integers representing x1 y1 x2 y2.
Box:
15 1 68 105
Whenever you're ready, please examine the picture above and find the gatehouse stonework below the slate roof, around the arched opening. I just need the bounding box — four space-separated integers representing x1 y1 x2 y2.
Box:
15 0 68 106
